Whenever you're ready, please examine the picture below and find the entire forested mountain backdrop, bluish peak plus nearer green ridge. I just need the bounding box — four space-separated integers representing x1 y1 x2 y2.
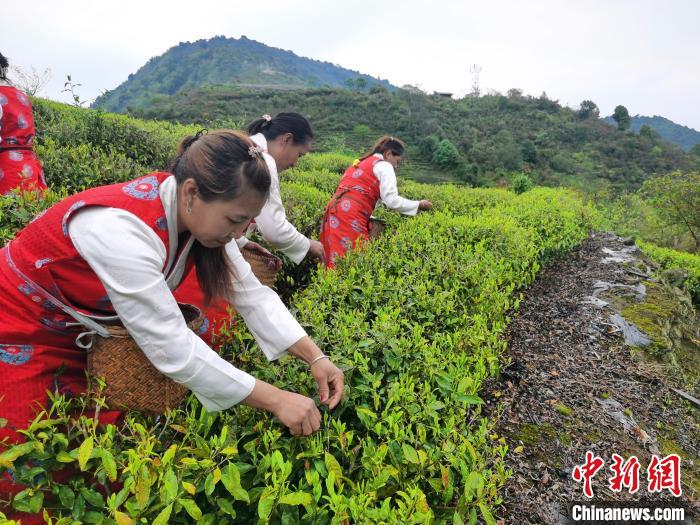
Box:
94 37 700 190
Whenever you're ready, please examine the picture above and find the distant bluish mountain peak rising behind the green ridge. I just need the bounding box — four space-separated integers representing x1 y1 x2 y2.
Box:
93 36 393 112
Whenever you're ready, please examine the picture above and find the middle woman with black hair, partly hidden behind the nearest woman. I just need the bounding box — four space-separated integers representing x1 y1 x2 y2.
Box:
175 113 323 343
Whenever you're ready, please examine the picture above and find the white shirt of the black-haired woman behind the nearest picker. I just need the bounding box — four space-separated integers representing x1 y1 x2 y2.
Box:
245 133 310 264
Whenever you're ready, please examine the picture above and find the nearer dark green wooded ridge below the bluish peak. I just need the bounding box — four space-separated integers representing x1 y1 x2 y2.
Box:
129 87 700 190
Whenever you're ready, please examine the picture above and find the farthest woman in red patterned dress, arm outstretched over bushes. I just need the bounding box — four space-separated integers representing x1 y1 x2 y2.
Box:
321 135 433 268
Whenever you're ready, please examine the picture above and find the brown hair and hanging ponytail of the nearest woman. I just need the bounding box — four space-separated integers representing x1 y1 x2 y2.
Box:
170 130 270 304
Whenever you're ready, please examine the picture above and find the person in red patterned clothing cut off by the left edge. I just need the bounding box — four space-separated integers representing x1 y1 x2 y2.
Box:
0 54 46 195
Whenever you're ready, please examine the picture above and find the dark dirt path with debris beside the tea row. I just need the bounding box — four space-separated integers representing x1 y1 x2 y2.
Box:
487 234 700 525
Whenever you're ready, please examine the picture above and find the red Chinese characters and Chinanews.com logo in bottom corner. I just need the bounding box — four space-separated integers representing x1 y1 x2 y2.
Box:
569 451 687 524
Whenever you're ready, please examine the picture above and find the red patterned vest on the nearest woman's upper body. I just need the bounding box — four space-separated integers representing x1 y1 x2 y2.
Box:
8 173 172 315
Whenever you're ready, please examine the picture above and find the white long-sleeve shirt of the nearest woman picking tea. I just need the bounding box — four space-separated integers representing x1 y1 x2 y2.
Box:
68 177 306 411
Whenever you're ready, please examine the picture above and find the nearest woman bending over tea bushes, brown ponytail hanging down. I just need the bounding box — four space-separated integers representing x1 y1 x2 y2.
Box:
0 130 343 520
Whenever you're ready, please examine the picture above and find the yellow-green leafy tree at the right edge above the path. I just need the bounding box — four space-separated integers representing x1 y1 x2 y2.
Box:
641 171 700 251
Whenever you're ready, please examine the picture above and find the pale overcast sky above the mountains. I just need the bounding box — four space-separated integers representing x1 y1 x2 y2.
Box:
5 0 700 130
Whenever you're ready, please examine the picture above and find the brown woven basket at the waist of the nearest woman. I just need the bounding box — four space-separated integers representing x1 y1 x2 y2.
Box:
87 304 204 414
